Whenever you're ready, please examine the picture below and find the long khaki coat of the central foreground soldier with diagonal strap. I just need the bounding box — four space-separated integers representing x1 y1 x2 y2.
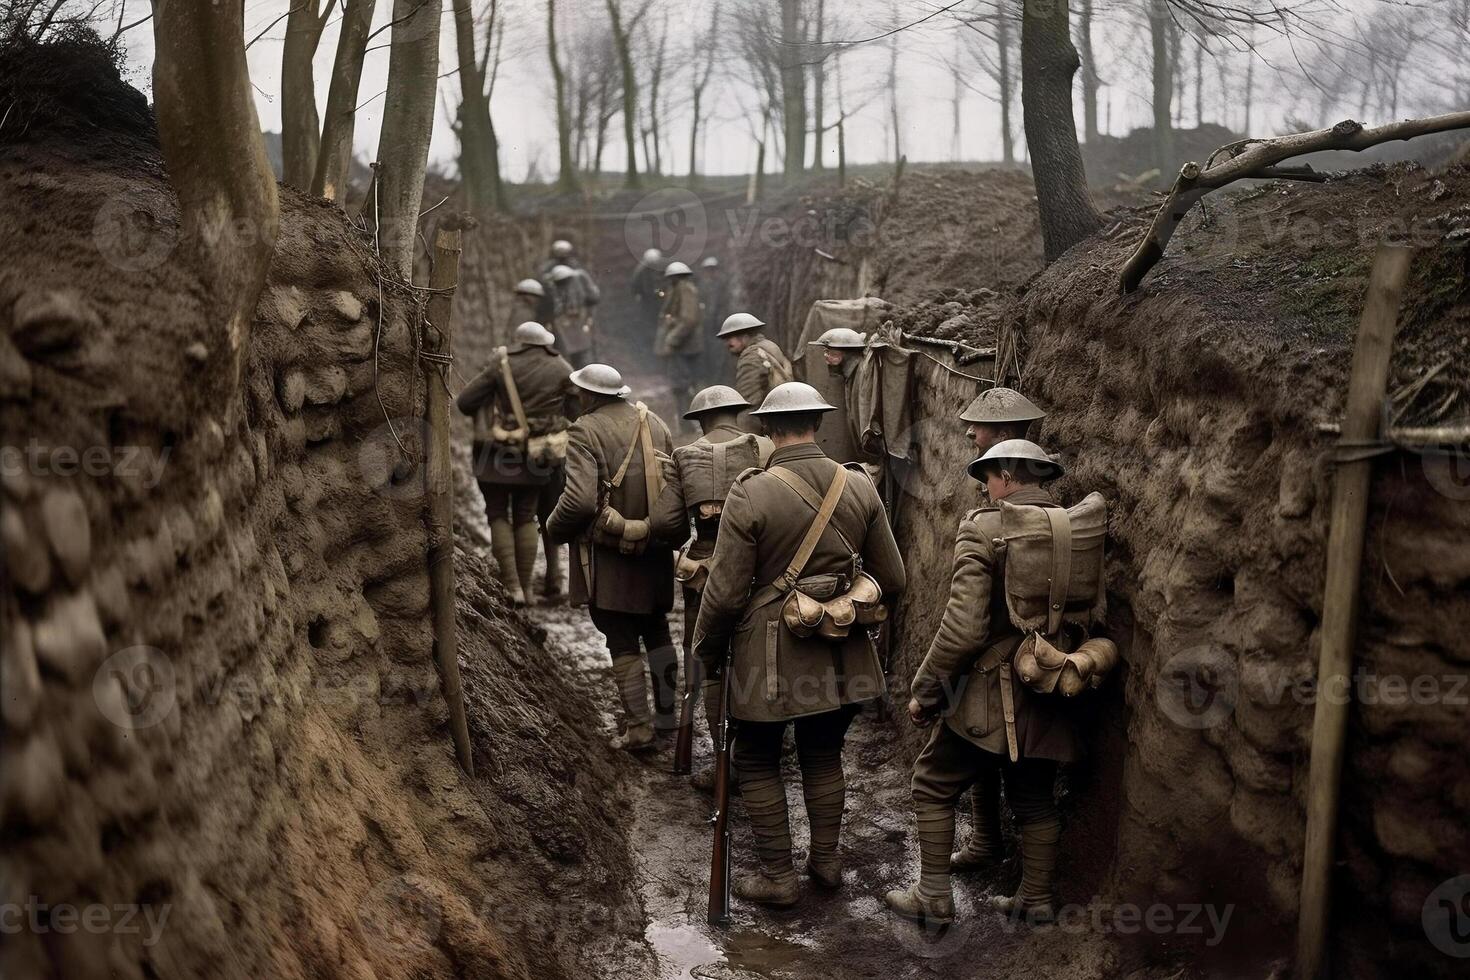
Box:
694 442 906 721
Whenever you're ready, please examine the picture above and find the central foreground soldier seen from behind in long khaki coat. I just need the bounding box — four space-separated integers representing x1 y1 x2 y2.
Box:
694 382 904 907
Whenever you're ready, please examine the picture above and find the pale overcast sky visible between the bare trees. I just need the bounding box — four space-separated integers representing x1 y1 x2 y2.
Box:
104 0 1467 181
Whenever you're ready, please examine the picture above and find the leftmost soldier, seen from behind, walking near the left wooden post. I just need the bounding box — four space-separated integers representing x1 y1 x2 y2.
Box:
456 323 576 605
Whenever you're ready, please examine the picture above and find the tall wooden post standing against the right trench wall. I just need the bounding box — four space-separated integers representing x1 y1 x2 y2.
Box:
1297 245 1413 980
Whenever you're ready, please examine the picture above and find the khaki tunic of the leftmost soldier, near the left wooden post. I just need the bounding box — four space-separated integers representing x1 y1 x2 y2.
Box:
454 344 578 485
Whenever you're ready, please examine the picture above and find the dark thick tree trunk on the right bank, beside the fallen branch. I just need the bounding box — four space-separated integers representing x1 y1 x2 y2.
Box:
1020 0 1103 262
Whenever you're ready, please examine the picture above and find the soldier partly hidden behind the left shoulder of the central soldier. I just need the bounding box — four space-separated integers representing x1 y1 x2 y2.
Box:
653 385 772 789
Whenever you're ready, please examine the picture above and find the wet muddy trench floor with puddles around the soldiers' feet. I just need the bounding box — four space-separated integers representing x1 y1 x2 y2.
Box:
528 566 1110 980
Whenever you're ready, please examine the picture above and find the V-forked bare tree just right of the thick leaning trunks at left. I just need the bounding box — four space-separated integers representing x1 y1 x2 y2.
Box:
454 0 506 212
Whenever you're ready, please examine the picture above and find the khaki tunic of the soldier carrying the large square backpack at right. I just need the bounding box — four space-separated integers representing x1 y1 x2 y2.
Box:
911 488 1078 763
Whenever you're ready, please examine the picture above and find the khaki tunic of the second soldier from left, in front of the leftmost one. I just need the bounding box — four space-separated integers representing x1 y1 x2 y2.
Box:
545 400 673 614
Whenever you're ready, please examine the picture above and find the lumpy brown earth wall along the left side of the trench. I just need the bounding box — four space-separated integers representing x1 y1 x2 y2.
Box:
0 44 637 977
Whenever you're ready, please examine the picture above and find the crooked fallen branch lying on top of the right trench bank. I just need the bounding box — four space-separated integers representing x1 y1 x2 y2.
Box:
1119 112 1470 292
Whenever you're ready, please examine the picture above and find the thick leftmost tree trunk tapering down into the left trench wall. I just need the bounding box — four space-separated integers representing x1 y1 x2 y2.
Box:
153 0 279 387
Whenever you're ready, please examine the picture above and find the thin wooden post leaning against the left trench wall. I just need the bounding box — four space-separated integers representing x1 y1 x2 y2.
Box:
420 217 475 776
